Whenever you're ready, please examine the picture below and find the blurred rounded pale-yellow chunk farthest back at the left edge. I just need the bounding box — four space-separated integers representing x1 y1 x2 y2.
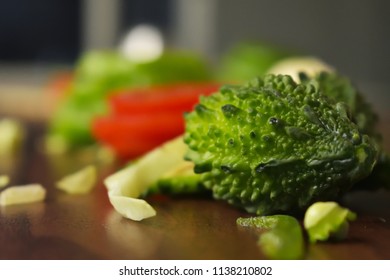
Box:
0 118 25 155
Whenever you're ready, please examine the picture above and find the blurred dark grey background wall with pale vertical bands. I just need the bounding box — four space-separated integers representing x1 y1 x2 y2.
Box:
0 0 390 84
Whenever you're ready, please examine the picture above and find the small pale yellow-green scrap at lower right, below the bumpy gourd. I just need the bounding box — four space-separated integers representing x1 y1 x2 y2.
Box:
304 201 356 243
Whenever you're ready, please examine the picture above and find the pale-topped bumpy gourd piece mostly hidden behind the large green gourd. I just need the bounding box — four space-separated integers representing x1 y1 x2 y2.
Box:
278 68 390 190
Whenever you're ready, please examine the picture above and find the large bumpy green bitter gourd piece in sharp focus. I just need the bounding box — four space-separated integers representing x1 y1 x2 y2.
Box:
184 75 378 215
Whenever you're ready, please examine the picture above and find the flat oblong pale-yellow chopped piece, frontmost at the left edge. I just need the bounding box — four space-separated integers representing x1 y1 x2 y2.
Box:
0 184 46 206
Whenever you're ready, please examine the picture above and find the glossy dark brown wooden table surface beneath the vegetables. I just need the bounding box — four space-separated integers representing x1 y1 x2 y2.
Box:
0 80 390 259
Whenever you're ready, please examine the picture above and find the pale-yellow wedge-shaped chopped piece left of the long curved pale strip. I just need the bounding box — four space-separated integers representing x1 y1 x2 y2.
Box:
57 165 97 194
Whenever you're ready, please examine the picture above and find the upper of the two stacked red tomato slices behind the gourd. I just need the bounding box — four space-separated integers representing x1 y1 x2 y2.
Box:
109 83 219 115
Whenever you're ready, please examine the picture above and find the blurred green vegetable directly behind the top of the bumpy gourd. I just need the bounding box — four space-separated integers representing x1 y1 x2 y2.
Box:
217 42 293 83
